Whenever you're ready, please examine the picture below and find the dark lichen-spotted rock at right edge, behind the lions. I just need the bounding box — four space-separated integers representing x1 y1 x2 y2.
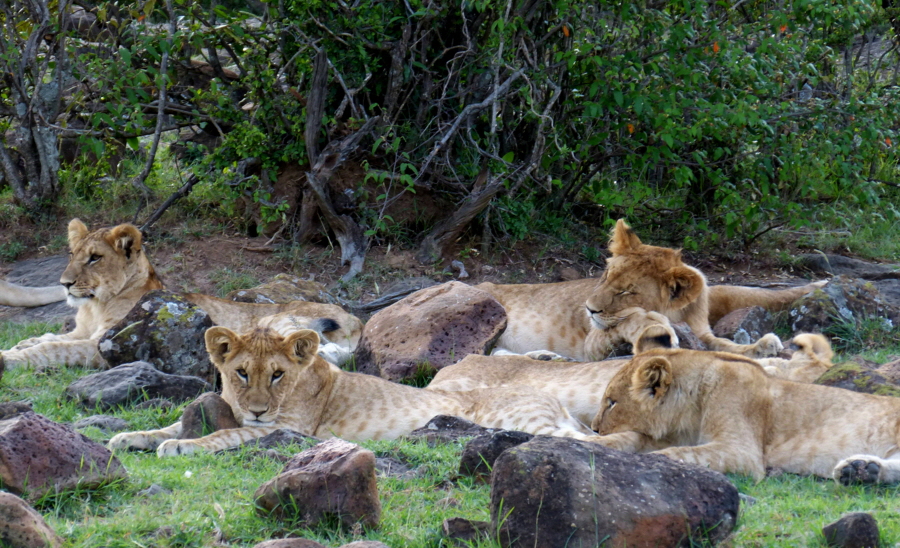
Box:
788 276 900 333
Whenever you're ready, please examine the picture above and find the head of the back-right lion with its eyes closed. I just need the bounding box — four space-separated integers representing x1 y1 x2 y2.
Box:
585 219 706 329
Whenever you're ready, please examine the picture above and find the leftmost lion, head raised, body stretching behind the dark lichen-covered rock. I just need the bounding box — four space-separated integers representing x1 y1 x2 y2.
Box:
0 219 362 368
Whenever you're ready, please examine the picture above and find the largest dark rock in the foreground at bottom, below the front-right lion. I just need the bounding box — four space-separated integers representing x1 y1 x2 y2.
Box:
491 436 740 548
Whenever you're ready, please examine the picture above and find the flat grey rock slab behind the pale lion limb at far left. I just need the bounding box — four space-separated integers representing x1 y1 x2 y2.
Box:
0 255 76 323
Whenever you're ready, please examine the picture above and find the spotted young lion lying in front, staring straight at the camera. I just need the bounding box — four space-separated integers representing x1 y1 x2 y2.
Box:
109 327 594 457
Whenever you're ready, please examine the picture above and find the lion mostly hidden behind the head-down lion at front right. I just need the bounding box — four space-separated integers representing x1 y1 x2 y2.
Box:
426 324 832 424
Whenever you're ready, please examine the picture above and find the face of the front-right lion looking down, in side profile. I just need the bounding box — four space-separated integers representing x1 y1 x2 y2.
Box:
591 351 672 438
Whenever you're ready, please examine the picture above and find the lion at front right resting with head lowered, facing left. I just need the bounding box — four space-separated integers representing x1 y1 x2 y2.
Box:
591 349 900 485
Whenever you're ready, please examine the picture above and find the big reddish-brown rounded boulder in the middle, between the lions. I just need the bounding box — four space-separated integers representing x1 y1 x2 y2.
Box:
356 282 506 381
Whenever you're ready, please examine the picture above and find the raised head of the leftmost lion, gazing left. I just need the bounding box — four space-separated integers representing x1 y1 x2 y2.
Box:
59 219 162 307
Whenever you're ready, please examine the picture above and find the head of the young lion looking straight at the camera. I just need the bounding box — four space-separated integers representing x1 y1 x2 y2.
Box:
206 327 331 428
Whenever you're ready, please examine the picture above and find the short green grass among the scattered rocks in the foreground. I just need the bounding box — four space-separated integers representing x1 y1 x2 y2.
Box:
8 323 900 548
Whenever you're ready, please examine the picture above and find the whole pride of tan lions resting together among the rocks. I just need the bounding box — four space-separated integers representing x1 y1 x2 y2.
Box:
0 219 900 485
